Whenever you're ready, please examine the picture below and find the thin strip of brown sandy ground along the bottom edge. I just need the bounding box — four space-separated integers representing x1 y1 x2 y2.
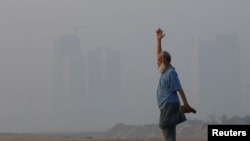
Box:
0 136 207 141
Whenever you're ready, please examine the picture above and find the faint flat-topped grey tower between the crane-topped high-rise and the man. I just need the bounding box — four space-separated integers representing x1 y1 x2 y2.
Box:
88 48 121 125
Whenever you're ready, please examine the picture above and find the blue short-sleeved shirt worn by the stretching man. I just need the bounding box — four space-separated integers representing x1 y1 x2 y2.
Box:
157 66 181 109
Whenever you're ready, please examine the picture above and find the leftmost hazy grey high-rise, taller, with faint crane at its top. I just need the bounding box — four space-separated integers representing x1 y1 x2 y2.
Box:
54 34 86 122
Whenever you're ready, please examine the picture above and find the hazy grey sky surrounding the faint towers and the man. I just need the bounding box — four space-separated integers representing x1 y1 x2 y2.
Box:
0 0 250 132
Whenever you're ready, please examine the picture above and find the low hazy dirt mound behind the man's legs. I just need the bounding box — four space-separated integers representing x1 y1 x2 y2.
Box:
101 122 207 139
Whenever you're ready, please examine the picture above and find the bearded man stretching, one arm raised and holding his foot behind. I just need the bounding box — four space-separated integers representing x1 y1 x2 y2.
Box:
156 28 196 141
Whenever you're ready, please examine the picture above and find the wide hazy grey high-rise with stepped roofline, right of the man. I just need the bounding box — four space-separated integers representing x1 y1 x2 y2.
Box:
199 33 242 118
